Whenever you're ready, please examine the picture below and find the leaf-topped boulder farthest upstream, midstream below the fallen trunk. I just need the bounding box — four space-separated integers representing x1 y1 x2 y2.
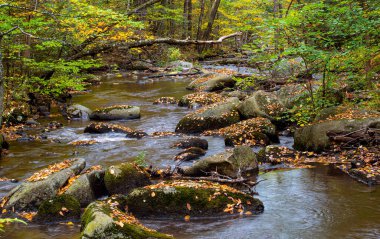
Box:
186 74 236 92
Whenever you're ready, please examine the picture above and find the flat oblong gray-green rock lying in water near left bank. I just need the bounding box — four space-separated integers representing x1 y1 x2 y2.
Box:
90 105 140 120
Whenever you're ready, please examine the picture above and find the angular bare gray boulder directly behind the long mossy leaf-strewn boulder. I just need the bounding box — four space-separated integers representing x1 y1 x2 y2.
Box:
183 146 258 178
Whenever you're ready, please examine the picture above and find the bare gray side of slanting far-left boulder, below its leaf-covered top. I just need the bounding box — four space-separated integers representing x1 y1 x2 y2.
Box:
4 159 86 211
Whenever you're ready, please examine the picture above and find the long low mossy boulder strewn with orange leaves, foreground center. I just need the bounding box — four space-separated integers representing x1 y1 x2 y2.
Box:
126 180 264 218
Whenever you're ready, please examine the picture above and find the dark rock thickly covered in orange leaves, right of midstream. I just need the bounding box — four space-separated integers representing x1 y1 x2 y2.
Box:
203 117 279 146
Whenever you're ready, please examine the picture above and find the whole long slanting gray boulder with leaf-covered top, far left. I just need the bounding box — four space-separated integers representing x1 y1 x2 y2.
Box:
3 159 86 211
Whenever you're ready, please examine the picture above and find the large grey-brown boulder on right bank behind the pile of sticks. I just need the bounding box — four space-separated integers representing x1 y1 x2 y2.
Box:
294 117 380 152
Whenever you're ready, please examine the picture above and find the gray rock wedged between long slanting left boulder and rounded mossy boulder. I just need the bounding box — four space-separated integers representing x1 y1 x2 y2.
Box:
62 166 107 207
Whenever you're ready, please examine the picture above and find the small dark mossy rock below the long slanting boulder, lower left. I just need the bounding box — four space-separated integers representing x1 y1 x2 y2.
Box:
36 195 81 221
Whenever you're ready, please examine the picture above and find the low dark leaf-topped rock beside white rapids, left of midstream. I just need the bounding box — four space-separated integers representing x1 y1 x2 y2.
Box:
84 123 147 138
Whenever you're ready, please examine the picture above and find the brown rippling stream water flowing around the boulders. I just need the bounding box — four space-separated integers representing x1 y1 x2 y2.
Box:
0 73 380 239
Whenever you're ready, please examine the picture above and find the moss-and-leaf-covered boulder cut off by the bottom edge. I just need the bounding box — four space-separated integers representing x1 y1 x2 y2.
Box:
81 200 173 239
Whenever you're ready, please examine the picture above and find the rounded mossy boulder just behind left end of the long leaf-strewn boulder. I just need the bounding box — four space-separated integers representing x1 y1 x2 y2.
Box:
104 163 151 195
